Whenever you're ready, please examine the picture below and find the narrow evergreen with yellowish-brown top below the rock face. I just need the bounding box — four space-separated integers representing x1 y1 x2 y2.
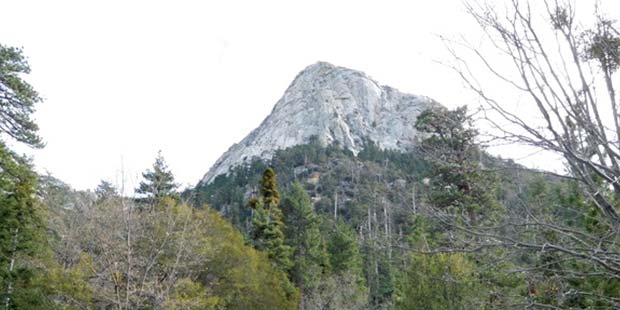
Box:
251 168 292 270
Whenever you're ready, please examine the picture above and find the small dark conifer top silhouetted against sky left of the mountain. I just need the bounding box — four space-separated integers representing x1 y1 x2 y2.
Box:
136 151 179 203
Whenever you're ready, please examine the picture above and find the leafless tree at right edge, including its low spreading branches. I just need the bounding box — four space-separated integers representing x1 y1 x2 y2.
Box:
426 0 620 307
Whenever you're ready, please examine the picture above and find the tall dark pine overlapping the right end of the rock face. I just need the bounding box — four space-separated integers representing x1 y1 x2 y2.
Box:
416 106 499 222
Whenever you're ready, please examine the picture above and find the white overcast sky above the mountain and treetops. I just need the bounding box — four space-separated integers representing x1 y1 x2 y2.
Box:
0 0 613 189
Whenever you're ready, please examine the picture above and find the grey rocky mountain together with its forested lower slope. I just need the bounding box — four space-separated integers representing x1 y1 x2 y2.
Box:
190 63 552 310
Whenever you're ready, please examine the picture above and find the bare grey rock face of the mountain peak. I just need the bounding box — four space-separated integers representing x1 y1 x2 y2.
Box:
201 62 437 184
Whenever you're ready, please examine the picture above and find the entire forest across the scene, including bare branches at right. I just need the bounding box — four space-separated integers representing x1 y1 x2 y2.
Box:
0 1 620 309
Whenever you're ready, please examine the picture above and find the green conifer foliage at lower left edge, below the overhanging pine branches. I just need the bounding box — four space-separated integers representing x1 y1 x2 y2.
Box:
0 143 46 309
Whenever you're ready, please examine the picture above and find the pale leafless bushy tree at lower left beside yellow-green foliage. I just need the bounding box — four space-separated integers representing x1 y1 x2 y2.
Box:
50 190 206 309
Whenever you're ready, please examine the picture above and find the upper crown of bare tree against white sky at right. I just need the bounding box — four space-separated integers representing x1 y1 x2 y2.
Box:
451 0 620 223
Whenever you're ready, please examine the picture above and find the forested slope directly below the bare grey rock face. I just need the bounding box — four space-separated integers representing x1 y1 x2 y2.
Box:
194 119 583 309
